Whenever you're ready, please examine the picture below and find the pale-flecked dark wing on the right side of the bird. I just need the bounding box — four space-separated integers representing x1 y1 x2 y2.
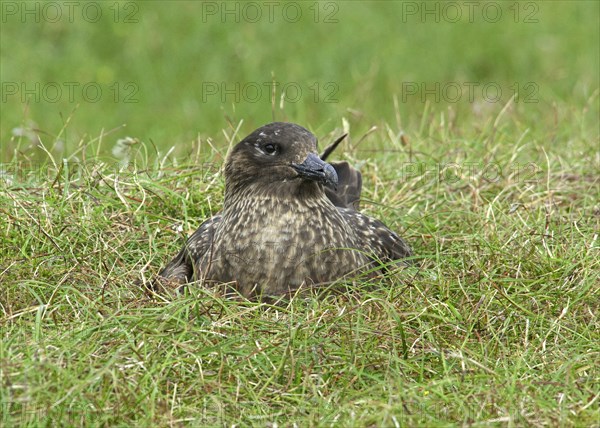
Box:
338 208 412 262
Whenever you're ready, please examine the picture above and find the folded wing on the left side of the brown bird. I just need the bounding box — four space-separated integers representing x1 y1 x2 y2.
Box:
158 215 221 284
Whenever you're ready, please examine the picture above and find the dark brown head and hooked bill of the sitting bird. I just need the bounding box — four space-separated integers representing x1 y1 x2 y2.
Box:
225 122 338 197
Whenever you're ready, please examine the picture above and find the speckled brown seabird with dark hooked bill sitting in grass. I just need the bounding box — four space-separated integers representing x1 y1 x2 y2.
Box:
155 122 412 300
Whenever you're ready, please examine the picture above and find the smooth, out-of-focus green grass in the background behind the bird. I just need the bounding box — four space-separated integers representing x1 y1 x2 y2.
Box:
0 1 600 155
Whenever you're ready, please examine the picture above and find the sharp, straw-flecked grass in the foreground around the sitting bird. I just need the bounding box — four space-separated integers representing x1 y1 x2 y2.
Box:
0 100 600 426
